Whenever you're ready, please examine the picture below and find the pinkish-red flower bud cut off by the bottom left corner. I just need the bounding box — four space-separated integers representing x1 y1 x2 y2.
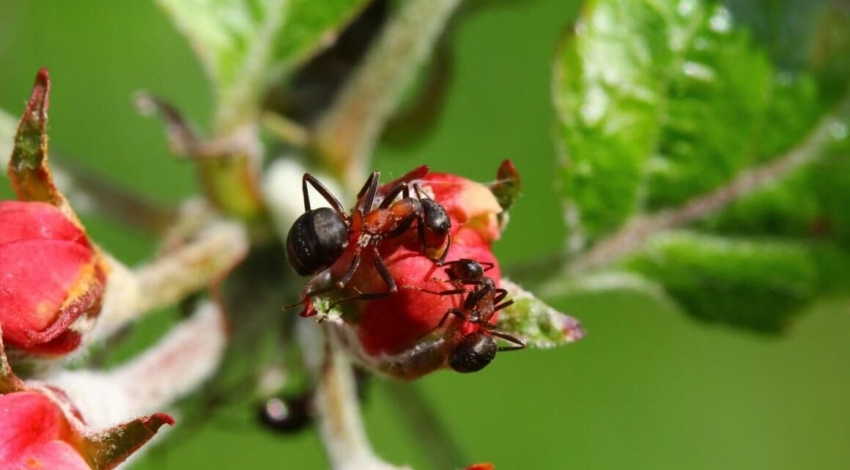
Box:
0 391 91 470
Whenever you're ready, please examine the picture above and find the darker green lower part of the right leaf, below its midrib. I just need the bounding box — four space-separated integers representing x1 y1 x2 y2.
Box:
625 232 822 331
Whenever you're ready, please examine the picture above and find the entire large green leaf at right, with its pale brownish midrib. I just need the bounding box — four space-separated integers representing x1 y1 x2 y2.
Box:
550 0 850 331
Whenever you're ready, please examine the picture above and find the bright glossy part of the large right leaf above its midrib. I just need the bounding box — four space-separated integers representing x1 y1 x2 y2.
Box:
555 0 840 246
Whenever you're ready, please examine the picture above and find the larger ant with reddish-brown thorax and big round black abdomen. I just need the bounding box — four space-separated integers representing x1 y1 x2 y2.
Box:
286 167 451 305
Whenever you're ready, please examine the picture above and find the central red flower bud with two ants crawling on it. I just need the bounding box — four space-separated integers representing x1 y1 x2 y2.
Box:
322 169 510 380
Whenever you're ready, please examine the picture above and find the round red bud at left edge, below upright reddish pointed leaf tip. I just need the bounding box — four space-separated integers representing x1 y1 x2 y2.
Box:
0 201 105 355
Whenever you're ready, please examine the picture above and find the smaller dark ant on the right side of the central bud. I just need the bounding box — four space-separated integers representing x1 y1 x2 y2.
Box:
410 258 525 372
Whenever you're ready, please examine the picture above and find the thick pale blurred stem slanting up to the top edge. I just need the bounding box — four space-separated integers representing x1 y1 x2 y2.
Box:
313 0 460 189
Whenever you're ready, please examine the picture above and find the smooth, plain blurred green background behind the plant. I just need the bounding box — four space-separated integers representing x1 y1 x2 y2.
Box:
0 0 850 470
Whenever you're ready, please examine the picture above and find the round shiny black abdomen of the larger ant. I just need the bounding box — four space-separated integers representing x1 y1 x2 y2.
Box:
286 207 349 276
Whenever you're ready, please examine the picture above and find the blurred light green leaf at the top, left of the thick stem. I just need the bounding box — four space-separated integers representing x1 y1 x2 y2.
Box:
157 0 366 134
